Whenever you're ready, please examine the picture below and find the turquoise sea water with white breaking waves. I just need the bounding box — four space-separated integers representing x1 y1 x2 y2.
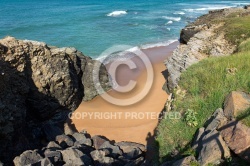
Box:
0 0 250 58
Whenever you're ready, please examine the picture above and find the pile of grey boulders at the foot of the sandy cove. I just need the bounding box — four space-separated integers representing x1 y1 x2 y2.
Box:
14 132 146 166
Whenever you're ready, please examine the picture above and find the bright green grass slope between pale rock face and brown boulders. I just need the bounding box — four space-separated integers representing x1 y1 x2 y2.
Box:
156 51 250 162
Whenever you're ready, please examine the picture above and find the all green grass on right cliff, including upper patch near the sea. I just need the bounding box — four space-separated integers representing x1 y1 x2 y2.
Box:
156 13 250 162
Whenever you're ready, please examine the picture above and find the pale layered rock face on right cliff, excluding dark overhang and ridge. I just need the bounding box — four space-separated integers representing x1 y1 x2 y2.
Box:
164 24 236 91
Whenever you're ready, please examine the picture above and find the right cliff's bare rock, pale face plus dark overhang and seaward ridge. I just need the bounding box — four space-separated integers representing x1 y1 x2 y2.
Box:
163 8 249 93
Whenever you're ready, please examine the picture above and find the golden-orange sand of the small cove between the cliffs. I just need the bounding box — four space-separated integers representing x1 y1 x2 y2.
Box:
72 42 178 144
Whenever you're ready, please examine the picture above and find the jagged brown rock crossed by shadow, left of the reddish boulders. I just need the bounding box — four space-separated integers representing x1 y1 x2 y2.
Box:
192 108 231 165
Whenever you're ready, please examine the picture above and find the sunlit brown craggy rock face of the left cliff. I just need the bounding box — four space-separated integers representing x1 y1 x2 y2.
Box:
0 37 84 119
